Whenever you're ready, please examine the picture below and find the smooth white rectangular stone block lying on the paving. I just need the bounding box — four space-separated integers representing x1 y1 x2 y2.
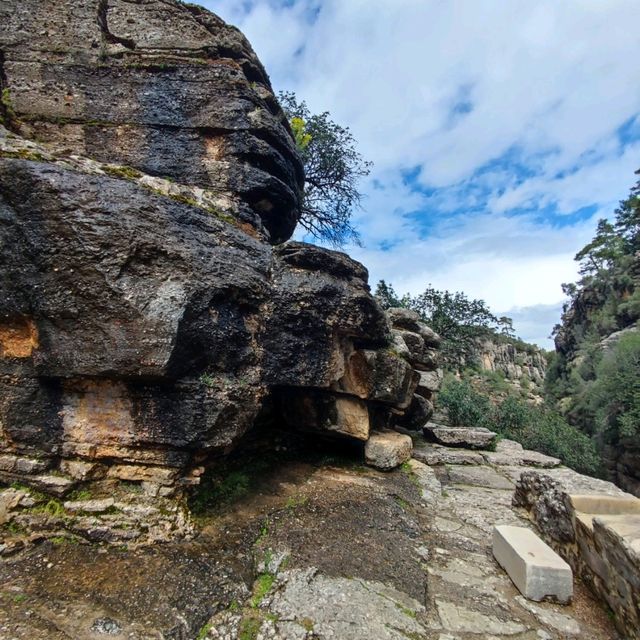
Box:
493 525 573 603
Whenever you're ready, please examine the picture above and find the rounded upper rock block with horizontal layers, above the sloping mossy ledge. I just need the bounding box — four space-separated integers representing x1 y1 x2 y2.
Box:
0 0 303 242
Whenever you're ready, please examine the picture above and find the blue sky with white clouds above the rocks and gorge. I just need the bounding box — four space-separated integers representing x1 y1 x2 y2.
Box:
201 0 640 348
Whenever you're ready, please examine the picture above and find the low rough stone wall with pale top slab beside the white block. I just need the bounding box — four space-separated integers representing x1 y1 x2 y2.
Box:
513 472 640 640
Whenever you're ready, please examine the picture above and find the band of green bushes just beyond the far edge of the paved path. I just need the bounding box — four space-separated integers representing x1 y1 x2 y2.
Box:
439 375 601 475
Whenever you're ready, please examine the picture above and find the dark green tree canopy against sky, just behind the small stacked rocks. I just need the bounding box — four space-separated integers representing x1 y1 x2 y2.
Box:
375 280 515 368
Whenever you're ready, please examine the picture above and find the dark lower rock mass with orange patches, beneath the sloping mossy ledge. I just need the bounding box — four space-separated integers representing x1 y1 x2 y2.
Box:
0 144 398 490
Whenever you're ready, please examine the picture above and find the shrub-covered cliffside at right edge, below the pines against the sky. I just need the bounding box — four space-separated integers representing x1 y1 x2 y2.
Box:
545 260 640 495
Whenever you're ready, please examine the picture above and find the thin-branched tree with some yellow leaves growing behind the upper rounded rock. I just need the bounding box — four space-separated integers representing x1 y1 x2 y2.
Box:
278 92 372 246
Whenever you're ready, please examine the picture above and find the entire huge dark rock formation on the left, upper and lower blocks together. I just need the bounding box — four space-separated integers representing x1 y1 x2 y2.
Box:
0 0 438 536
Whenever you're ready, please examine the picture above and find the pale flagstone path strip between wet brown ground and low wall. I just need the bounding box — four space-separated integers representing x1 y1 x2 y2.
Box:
414 440 619 640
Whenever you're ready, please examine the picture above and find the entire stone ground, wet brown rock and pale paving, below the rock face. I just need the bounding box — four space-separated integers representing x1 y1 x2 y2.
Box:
0 445 618 640
